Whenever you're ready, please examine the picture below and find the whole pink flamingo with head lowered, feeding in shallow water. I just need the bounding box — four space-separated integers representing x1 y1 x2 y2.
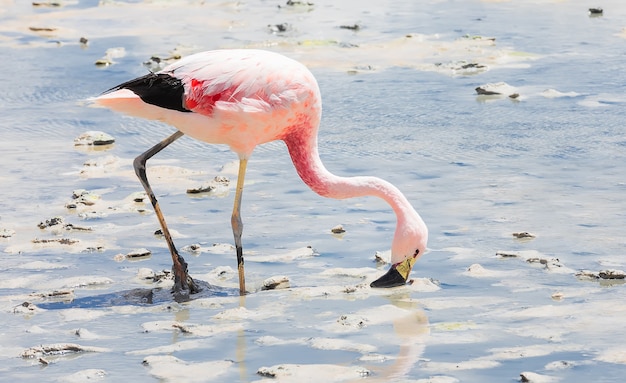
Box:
94 49 428 297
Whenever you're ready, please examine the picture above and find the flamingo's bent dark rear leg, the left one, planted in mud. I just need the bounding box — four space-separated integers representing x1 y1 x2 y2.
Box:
133 131 200 300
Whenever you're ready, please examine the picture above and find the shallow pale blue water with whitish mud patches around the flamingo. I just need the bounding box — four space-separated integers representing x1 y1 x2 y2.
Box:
0 1 626 382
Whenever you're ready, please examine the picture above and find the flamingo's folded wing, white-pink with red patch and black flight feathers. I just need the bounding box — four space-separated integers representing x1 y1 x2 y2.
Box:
100 49 315 117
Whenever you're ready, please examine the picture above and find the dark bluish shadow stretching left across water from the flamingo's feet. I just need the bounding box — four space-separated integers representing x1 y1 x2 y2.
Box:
37 280 239 310
